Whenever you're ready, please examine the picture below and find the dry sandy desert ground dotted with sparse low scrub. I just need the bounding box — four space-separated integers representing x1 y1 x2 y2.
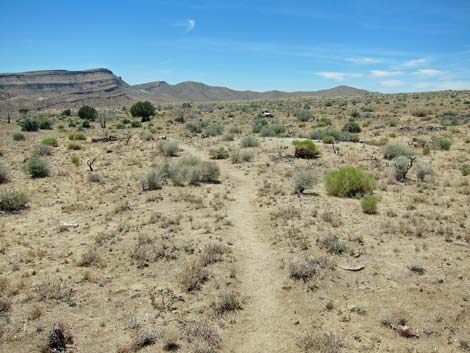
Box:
0 91 470 353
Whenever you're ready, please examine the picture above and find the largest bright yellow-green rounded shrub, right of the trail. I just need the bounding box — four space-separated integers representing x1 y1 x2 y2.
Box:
325 167 376 197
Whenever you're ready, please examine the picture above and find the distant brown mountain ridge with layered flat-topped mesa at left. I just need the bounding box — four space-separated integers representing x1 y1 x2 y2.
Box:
0 68 369 111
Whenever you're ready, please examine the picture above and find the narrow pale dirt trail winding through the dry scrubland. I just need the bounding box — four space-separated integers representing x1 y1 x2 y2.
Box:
186 143 295 353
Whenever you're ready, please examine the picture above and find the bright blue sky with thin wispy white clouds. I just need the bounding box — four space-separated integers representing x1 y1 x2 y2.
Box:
0 0 470 92
